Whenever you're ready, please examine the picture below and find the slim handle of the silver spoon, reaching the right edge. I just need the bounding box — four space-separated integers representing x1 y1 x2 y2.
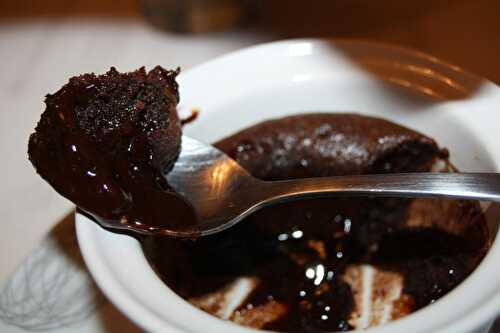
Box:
263 173 500 203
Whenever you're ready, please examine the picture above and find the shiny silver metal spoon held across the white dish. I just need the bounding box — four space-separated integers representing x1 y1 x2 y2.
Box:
158 136 500 237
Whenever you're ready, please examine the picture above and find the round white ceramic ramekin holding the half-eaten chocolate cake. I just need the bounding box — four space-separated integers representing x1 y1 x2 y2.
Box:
77 40 500 333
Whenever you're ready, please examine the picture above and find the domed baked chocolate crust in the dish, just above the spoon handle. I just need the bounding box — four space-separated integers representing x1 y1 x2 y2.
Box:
217 113 447 179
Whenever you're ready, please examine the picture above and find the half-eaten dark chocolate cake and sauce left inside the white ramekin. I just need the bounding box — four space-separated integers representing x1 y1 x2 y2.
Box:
143 114 488 332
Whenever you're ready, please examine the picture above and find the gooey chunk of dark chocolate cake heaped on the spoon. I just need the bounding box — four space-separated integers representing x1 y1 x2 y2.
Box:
28 66 181 226
